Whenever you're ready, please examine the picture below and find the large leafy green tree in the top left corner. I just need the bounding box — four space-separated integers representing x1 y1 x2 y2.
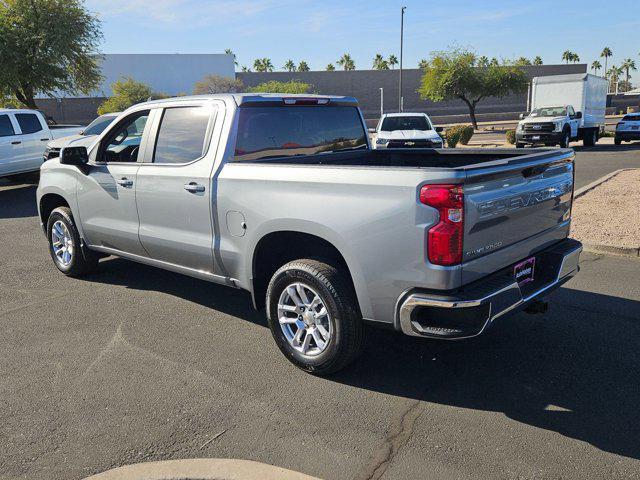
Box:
0 0 102 108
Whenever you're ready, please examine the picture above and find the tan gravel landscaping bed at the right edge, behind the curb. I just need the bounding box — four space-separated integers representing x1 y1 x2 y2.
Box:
571 169 640 249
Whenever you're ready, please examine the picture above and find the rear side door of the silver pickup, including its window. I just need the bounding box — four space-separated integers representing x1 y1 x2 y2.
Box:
136 101 218 273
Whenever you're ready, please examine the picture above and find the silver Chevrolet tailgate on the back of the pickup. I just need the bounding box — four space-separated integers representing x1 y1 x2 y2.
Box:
463 150 574 270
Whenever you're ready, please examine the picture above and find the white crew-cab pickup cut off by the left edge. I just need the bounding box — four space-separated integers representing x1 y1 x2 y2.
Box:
0 109 82 177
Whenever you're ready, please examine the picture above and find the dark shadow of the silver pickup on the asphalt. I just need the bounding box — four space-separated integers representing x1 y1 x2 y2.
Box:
87 255 640 459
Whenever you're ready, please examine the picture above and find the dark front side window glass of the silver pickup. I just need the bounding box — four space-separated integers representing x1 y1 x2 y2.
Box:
100 110 149 163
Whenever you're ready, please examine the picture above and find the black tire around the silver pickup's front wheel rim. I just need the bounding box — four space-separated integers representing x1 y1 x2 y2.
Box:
47 207 99 277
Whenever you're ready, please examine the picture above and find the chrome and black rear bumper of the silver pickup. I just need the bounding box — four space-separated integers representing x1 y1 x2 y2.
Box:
397 239 582 340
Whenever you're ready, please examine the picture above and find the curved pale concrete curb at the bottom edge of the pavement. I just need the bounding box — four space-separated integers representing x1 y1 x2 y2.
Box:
85 458 320 480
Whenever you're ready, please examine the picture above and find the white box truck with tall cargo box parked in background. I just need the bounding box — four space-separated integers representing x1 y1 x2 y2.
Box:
516 73 607 148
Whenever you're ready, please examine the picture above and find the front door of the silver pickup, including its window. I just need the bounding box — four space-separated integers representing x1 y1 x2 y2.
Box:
78 110 150 256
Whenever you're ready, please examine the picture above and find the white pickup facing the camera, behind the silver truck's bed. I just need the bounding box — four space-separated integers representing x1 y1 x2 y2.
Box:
369 112 442 148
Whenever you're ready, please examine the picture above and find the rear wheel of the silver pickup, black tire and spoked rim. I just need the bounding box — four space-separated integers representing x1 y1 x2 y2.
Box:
266 259 364 375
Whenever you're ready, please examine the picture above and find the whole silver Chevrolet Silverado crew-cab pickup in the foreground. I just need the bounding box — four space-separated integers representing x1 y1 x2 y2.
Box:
37 94 582 375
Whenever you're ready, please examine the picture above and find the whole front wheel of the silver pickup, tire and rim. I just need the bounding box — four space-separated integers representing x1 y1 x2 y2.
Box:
47 207 98 277
